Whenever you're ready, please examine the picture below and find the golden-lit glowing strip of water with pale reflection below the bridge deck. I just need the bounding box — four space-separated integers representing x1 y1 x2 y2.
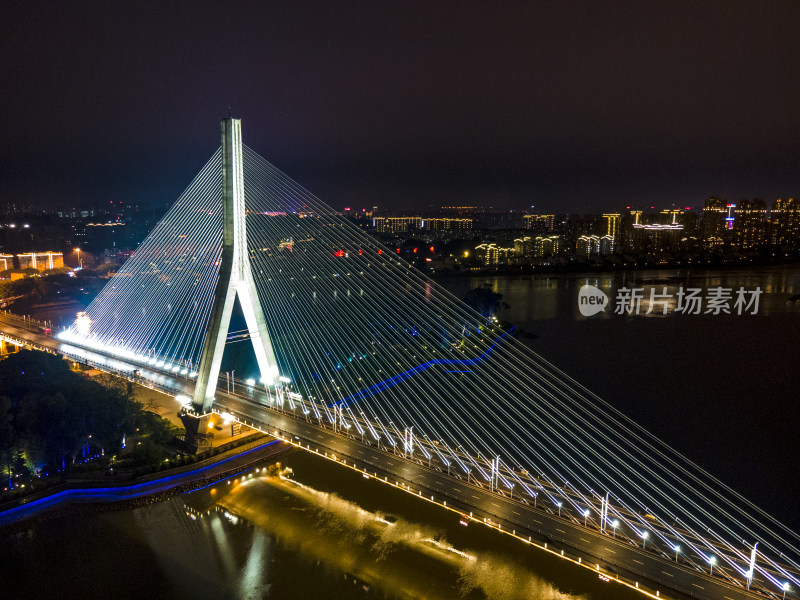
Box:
200 468 580 600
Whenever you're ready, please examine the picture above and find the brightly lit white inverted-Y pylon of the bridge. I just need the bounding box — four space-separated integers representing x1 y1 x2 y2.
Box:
192 117 278 414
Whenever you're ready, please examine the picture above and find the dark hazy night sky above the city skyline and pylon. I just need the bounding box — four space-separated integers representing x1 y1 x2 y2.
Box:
0 0 800 211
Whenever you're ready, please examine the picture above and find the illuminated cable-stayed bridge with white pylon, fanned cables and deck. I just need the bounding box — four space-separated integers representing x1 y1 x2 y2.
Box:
7 119 800 598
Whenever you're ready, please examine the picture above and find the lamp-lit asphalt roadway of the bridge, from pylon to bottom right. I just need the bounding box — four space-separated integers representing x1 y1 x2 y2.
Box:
215 393 764 600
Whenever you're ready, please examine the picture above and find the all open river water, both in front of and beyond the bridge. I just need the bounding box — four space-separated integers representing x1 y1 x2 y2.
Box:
6 266 800 600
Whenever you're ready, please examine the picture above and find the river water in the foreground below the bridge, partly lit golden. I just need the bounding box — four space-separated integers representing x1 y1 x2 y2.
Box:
0 451 640 600
